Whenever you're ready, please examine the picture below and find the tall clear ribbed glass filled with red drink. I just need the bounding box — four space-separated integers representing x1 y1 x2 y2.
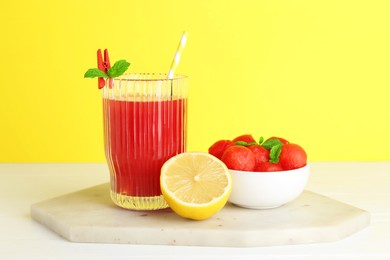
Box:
103 73 188 210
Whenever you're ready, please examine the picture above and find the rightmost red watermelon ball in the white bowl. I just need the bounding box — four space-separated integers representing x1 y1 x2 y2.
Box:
279 143 307 170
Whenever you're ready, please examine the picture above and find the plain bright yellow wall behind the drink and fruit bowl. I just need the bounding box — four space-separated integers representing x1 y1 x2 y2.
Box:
0 0 390 162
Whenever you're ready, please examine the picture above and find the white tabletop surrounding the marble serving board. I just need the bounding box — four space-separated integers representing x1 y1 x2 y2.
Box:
0 162 390 260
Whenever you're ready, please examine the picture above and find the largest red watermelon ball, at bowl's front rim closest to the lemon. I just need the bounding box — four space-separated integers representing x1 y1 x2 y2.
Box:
221 145 256 171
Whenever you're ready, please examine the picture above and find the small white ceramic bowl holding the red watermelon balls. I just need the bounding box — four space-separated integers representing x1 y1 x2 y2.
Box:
229 165 310 209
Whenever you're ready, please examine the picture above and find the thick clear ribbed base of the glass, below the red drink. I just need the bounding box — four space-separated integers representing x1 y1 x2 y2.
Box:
111 191 168 210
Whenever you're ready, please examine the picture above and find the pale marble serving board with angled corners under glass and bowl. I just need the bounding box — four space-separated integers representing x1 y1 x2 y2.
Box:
31 184 370 247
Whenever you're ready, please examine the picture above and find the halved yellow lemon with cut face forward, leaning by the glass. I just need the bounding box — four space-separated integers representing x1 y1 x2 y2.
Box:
160 152 232 220
